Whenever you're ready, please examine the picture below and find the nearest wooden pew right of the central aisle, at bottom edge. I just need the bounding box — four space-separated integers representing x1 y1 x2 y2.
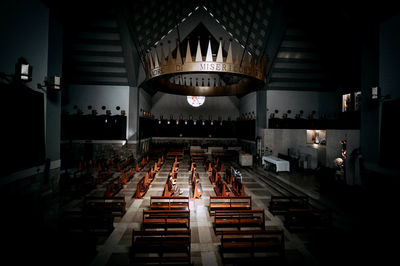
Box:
220 229 285 265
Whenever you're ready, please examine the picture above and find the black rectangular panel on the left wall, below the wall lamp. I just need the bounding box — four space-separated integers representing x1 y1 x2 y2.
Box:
0 83 45 175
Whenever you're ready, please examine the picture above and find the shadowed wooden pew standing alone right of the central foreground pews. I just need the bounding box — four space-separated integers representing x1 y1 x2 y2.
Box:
268 196 310 215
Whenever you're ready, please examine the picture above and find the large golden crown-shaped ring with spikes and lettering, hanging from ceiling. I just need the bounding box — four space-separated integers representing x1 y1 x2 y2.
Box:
144 39 266 96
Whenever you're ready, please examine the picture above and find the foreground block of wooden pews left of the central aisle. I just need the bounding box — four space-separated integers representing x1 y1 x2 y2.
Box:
130 196 191 264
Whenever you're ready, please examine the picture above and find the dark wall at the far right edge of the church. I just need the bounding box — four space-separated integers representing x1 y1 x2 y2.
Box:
360 16 400 166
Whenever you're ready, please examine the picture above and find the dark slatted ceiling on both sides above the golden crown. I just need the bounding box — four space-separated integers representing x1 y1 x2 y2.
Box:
44 0 398 94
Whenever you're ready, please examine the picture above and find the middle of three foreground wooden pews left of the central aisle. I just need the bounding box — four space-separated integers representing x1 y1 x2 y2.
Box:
142 210 190 230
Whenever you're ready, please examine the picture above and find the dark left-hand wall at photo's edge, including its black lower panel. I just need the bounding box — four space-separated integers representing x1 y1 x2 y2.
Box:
0 0 49 175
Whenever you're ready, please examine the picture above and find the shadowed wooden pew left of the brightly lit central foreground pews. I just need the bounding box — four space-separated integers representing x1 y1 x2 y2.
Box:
83 196 126 217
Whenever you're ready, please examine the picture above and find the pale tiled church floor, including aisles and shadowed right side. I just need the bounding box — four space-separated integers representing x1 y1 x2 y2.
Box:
58 157 396 266
